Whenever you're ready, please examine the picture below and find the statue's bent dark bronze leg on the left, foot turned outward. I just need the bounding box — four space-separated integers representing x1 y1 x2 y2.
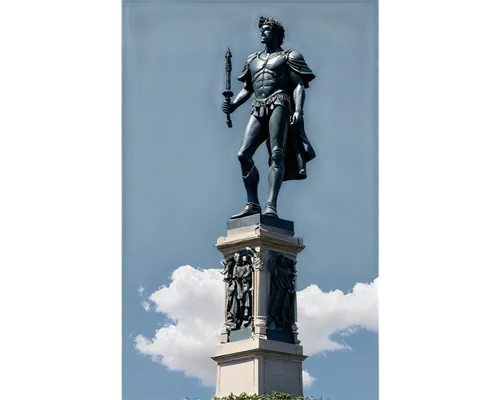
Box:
231 115 267 219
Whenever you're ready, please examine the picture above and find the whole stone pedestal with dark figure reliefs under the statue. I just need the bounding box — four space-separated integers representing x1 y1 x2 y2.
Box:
212 215 306 397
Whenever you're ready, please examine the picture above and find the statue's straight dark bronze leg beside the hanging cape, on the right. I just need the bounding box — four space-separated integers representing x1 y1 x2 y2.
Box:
264 106 289 217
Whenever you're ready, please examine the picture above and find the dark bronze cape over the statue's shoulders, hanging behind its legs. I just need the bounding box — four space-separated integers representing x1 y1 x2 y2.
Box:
238 49 316 181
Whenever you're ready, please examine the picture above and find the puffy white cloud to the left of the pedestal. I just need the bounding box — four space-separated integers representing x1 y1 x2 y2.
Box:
135 266 224 386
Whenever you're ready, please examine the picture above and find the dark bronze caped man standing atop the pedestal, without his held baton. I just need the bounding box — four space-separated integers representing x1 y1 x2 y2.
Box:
222 17 316 219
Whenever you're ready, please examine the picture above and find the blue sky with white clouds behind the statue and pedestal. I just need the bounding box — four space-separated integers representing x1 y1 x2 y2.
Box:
120 0 380 400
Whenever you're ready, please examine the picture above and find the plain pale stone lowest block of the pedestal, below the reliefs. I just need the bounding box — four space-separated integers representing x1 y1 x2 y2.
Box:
212 339 307 397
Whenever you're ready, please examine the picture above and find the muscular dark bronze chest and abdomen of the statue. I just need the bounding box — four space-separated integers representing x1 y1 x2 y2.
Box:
249 51 291 99
